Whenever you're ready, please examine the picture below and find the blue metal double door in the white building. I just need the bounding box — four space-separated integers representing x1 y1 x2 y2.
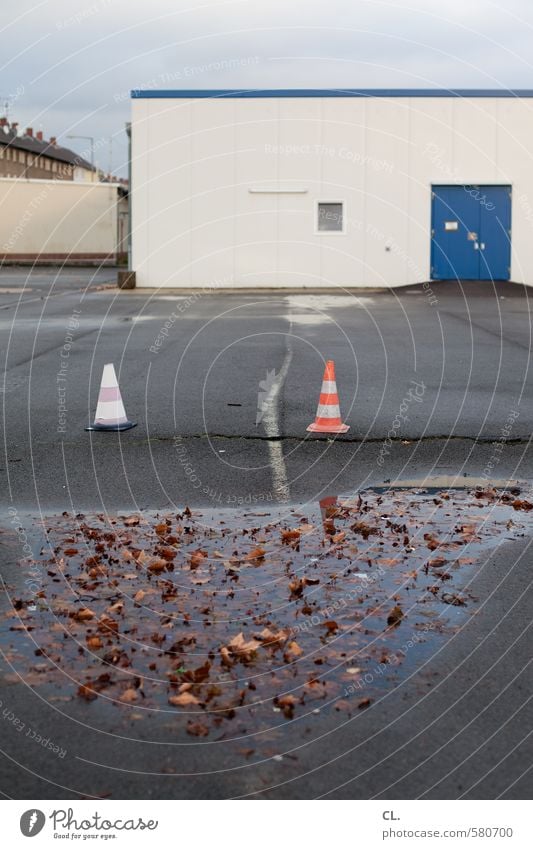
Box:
431 186 511 280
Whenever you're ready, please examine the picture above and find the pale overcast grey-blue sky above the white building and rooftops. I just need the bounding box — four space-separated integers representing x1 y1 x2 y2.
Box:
0 0 533 174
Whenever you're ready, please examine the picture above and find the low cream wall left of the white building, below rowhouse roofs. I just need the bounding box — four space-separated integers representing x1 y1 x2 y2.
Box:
0 179 118 264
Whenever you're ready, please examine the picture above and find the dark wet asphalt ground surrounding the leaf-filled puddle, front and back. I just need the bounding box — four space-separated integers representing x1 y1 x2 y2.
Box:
0 269 533 799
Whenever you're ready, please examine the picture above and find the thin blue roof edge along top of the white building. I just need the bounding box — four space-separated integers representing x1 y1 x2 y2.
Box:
131 88 533 99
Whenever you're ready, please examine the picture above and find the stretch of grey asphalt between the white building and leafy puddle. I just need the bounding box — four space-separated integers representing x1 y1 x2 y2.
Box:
0 269 533 510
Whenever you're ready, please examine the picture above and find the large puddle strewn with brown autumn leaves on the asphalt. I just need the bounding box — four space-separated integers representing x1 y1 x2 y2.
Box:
0 478 533 741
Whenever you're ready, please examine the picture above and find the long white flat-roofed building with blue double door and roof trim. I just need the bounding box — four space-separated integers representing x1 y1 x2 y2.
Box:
131 89 533 288
